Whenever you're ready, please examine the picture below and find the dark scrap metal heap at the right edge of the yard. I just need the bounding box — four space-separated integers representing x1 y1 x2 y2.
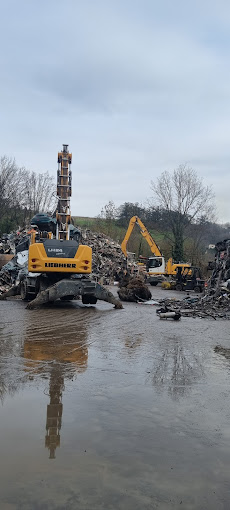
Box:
161 239 230 319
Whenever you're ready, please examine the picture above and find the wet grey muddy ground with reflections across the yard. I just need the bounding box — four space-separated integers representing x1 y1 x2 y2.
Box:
0 288 230 510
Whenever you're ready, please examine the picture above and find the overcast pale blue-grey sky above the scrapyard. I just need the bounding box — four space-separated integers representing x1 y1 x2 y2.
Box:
0 0 230 222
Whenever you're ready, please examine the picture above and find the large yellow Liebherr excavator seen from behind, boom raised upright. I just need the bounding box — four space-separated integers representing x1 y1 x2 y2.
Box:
1 145 122 309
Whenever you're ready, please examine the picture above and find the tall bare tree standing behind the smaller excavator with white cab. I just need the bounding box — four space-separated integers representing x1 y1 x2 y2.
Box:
151 164 215 261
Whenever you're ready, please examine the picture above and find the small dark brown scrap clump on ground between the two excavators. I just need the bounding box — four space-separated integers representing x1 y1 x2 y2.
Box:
118 274 152 303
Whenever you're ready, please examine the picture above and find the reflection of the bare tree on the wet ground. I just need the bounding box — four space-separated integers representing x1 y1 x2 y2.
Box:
151 338 204 399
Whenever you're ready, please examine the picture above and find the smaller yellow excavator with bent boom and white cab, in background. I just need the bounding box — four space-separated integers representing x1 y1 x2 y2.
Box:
121 216 190 286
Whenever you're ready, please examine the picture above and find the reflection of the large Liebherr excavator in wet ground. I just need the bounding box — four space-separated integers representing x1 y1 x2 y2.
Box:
24 314 88 459
